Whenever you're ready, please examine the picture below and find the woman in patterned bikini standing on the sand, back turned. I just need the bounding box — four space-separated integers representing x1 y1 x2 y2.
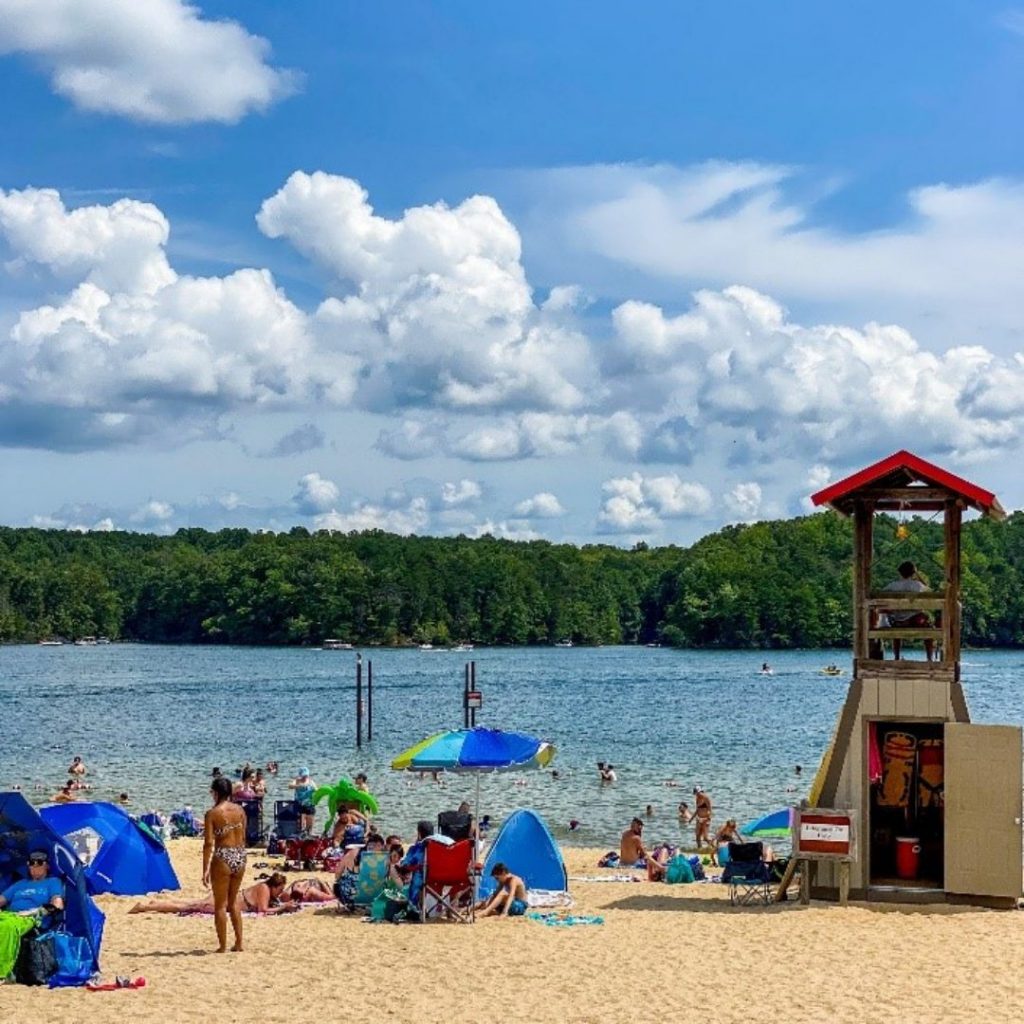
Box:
203 775 246 953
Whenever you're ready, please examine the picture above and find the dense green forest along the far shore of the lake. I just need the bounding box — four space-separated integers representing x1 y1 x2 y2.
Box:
0 512 1024 648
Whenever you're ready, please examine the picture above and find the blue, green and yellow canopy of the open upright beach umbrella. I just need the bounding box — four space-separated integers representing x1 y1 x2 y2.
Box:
391 728 555 772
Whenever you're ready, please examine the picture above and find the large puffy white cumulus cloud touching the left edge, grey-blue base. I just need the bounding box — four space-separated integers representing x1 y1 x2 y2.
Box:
0 189 357 450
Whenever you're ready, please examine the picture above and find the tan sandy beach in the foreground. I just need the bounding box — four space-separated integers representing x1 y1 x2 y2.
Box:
0 840 1024 1024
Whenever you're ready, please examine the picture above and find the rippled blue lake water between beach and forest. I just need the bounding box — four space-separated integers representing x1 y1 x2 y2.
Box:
0 644 1024 848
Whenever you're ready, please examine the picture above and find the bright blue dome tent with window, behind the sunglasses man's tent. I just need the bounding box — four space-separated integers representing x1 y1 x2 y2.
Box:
39 803 181 896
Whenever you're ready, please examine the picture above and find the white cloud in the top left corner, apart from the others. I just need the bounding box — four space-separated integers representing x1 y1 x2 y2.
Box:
0 0 298 124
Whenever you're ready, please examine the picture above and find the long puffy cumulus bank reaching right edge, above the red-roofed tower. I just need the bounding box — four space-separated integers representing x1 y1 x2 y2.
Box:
612 287 1024 464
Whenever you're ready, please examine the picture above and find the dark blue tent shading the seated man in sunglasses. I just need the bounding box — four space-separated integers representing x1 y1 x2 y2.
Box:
0 793 105 983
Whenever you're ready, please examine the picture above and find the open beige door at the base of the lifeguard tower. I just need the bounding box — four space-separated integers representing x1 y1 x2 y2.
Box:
945 722 1022 900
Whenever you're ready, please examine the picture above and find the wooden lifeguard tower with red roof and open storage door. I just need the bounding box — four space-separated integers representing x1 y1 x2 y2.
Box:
810 452 1022 905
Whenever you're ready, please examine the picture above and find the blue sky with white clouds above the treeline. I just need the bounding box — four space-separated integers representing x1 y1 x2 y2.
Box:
0 0 1024 545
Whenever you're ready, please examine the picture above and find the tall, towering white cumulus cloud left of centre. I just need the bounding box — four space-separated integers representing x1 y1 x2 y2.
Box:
257 172 598 412
